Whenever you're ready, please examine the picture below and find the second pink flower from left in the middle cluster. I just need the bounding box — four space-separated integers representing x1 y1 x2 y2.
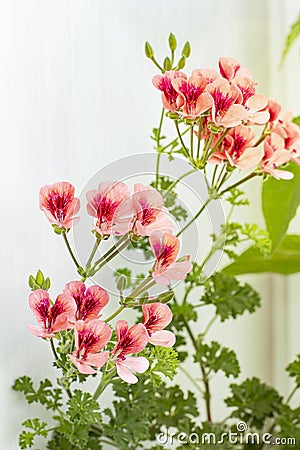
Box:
86 181 130 235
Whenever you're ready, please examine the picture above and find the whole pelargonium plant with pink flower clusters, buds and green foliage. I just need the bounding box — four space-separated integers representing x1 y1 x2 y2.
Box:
14 34 300 450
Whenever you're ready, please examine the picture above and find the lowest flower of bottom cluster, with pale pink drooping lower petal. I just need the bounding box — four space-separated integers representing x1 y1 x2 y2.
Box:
112 320 149 384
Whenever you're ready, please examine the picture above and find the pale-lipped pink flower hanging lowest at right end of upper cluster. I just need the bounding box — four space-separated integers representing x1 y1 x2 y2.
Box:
261 133 294 180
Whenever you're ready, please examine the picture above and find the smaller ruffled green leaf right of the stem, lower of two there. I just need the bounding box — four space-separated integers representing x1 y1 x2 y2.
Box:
194 342 240 378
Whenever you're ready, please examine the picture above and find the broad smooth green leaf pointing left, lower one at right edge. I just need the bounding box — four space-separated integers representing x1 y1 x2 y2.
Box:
223 234 300 275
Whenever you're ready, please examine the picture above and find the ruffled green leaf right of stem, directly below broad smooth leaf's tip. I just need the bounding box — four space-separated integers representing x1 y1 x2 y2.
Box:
201 272 260 322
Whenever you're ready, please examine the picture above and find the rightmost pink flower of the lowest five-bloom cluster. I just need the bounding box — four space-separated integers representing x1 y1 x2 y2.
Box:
142 303 175 347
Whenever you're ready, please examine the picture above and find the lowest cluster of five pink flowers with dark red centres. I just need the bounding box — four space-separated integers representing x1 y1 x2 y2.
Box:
29 281 175 383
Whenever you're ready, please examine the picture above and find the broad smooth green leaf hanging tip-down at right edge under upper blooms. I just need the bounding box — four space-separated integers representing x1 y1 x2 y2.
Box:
262 163 300 250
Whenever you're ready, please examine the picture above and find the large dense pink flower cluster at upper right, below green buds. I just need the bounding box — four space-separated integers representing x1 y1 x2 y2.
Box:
153 57 300 179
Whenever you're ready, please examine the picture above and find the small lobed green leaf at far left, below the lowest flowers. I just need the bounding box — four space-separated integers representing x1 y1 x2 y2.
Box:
13 376 62 411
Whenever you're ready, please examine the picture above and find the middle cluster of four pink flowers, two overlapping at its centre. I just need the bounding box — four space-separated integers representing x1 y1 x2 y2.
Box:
40 181 192 285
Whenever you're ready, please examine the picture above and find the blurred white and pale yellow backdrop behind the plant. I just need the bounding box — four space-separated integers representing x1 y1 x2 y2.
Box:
0 0 300 450
